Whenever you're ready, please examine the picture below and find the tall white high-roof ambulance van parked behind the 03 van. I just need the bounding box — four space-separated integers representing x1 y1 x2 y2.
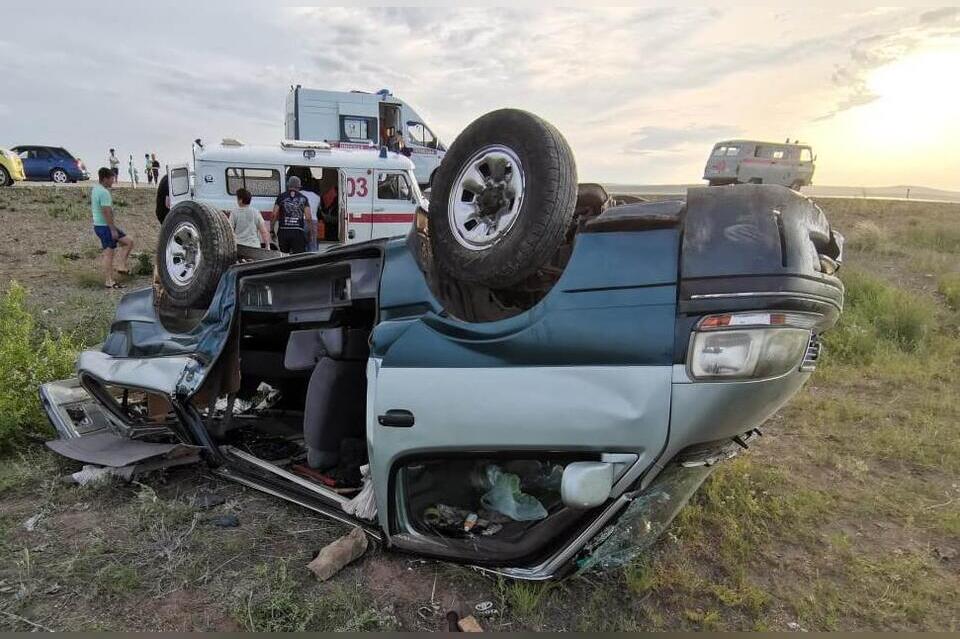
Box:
284 85 446 187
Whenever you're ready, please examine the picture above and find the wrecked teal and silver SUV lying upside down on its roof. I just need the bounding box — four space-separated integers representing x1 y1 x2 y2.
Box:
41 110 843 579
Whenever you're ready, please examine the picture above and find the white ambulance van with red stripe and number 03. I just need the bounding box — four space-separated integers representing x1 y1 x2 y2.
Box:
169 139 426 248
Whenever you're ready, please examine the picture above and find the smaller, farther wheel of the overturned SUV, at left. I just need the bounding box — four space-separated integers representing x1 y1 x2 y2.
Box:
156 201 237 308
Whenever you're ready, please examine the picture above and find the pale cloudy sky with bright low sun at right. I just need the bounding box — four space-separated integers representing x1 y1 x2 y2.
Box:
0 5 960 190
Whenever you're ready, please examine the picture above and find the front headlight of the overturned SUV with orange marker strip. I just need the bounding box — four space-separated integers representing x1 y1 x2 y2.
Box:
687 311 822 380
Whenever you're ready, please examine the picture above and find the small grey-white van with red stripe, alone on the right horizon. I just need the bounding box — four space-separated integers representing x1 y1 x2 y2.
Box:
703 140 817 190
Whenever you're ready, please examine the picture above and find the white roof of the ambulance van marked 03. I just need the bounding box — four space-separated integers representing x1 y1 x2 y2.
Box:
195 142 413 170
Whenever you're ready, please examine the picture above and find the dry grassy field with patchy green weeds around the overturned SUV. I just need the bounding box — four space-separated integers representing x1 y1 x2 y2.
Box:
0 187 960 631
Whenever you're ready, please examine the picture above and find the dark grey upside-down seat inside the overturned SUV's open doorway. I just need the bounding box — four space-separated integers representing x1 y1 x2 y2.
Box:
284 327 370 469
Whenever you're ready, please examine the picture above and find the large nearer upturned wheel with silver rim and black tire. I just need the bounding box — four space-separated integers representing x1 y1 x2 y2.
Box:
429 109 577 289
